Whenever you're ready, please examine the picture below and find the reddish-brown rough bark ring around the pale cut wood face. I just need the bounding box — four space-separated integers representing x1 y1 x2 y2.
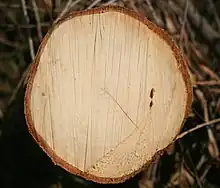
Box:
24 6 192 184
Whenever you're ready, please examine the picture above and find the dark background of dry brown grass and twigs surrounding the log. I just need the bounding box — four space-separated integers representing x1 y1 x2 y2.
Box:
0 0 220 188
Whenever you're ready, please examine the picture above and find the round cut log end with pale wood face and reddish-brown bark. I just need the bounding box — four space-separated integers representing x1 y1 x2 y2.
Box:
25 6 192 183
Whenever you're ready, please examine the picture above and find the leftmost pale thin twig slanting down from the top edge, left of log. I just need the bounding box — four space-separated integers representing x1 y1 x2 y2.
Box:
21 0 35 61
